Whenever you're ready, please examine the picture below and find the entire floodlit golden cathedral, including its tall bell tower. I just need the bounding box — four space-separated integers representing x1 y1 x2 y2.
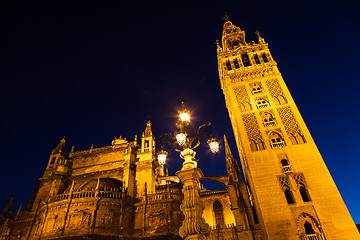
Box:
0 19 360 240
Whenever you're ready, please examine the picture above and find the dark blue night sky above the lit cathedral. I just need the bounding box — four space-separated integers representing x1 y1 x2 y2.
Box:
0 0 360 223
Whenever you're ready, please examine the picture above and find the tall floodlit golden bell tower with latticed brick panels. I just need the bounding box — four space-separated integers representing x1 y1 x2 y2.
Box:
217 19 360 240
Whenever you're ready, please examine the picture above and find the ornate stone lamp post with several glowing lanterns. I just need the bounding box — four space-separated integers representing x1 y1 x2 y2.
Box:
158 104 219 240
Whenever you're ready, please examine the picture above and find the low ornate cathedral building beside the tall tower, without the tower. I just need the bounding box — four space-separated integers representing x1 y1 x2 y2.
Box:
3 122 262 239
